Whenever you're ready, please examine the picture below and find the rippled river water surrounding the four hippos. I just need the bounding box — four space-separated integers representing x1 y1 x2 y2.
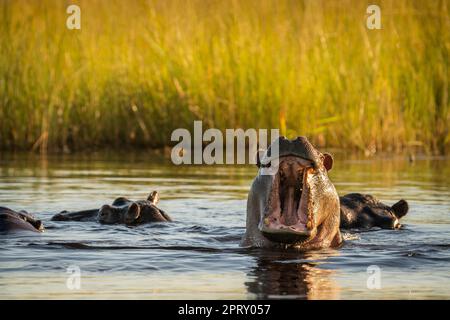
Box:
0 154 450 299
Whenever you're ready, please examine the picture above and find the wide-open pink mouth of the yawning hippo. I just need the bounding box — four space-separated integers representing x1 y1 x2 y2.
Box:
259 156 315 243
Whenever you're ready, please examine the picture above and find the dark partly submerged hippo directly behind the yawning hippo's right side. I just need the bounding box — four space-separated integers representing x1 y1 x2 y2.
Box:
340 193 409 229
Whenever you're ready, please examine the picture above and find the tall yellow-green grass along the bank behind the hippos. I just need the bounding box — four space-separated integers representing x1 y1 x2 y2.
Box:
0 0 450 153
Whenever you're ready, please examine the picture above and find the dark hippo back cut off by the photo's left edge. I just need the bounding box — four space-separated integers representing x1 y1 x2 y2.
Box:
0 207 44 232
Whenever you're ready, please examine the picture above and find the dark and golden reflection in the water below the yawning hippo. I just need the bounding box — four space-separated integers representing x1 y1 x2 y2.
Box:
245 250 340 300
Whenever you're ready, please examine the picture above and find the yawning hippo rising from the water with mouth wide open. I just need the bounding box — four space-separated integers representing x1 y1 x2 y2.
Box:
241 137 343 251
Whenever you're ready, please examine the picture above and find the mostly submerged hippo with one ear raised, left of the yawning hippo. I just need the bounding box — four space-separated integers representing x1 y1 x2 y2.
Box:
52 191 172 226
